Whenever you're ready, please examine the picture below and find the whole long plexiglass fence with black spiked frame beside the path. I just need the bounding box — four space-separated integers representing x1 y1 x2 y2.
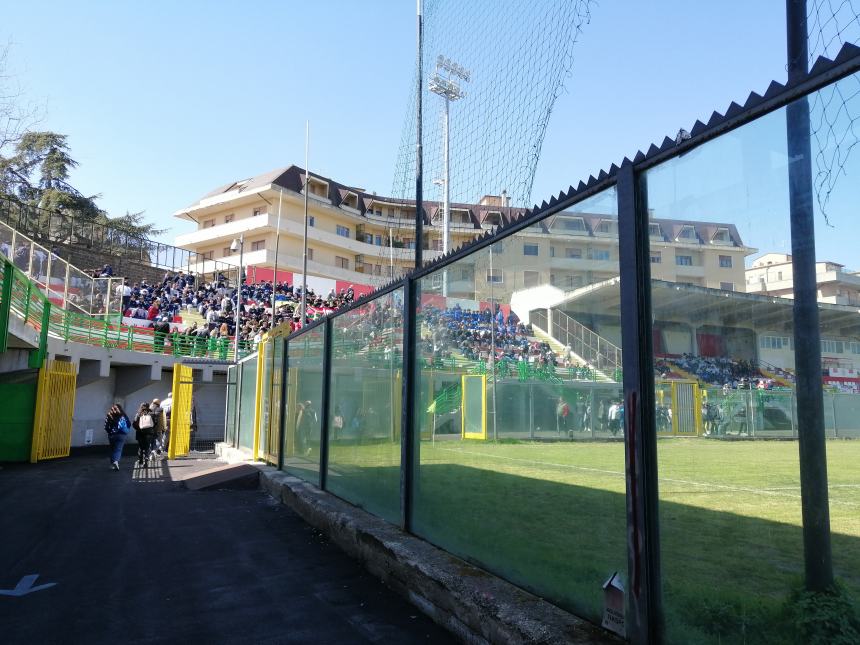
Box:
226 49 860 644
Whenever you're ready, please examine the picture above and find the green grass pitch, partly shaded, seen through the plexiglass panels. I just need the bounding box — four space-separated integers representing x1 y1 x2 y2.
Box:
329 438 860 643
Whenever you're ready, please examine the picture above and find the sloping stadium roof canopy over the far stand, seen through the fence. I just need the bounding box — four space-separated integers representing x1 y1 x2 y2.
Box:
554 278 860 337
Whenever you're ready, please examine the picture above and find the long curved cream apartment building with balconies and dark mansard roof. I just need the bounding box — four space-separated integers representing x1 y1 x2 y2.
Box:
175 166 755 298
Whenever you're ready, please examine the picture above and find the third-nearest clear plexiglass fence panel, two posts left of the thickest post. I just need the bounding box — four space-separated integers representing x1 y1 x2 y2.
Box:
326 289 403 522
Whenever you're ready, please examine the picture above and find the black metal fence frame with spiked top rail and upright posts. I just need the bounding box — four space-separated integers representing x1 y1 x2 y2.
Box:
232 44 860 644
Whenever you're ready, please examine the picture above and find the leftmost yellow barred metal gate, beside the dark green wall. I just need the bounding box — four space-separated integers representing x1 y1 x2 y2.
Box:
30 361 78 463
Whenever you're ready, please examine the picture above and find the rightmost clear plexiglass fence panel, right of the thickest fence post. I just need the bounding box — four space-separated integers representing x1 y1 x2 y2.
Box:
643 71 860 643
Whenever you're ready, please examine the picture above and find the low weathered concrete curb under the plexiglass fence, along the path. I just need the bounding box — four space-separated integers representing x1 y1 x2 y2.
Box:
216 444 623 645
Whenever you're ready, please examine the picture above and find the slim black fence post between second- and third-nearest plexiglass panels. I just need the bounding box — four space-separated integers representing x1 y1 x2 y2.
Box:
400 277 418 531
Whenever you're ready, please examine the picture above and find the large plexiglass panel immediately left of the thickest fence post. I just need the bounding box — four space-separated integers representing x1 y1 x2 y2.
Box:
414 188 627 623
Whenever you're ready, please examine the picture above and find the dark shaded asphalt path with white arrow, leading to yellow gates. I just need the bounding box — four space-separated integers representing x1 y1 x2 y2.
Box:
0 454 455 645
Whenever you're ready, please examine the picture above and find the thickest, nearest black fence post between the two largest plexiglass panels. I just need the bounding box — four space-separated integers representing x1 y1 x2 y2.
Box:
617 160 663 645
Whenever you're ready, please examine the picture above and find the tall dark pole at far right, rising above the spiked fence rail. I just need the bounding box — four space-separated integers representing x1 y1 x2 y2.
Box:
785 0 833 591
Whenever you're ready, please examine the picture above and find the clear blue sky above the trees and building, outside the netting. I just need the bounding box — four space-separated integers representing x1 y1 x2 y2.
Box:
0 0 828 249
